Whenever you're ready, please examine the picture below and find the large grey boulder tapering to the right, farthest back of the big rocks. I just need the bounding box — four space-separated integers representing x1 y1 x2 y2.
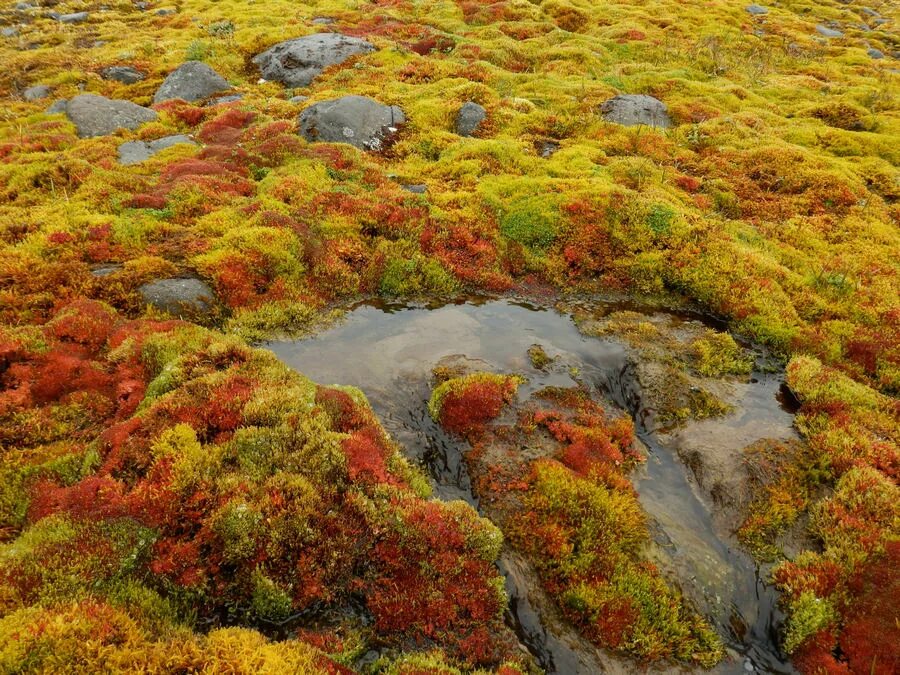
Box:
253 33 375 87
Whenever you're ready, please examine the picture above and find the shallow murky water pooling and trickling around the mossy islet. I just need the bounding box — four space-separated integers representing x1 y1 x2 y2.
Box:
267 299 794 673
